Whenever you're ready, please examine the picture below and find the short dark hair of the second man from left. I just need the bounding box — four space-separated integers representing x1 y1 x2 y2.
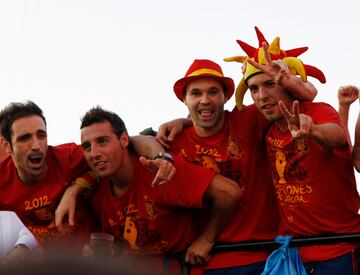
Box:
80 106 127 137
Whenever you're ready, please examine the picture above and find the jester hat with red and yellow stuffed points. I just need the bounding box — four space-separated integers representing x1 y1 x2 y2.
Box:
224 27 326 110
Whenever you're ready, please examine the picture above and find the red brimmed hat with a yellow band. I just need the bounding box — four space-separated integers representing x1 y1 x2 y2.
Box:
174 59 235 101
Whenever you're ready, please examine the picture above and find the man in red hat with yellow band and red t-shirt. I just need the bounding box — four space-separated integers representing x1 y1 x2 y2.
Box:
155 52 316 274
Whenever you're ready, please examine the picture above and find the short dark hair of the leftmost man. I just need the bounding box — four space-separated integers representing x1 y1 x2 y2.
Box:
0 100 46 146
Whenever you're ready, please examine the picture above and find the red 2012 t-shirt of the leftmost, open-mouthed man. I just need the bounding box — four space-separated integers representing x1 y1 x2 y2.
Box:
0 143 94 253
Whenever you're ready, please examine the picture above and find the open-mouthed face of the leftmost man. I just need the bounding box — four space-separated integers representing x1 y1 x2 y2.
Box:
11 115 48 184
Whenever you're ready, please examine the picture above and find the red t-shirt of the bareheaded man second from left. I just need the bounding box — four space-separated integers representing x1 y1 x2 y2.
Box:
92 156 215 273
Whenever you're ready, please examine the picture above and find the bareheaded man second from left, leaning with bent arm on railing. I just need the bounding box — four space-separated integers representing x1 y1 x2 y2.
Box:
59 107 242 274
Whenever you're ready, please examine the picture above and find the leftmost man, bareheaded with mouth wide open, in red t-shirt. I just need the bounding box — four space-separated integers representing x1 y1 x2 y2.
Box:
0 101 94 254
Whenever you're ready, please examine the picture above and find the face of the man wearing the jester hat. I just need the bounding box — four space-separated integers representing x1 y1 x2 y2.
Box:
247 73 292 121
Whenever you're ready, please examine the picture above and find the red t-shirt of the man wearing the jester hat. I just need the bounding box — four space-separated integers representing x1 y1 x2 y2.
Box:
266 102 360 262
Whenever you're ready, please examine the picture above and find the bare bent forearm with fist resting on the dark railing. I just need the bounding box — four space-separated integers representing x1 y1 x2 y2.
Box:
185 174 243 264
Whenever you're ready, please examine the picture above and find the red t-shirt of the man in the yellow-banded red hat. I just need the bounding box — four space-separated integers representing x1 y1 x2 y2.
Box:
171 105 279 268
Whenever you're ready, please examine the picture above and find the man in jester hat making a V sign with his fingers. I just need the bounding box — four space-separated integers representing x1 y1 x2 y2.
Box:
236 29 360 274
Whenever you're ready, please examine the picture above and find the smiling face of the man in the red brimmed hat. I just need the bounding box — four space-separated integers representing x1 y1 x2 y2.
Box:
184 77 226 136
